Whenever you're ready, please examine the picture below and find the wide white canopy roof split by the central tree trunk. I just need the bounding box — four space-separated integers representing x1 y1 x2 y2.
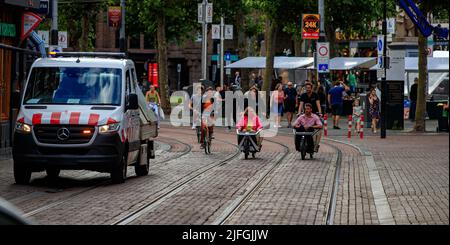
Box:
225 56 314 69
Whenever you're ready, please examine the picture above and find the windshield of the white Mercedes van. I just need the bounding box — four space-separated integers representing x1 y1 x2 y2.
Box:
24 67 122 105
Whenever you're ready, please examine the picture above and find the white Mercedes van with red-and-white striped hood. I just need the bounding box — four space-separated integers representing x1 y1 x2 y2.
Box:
13 53 158 184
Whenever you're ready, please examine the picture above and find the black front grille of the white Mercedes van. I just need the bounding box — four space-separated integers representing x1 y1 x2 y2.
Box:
33 125 95 144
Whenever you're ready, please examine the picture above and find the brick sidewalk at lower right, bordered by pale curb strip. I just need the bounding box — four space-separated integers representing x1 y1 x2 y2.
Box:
331 133 449 225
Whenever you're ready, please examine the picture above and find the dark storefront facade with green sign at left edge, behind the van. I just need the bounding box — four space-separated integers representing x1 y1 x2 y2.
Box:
0 0 40 156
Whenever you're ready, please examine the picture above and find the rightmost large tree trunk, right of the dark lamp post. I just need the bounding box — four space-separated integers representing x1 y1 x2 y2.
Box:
414 32 428 132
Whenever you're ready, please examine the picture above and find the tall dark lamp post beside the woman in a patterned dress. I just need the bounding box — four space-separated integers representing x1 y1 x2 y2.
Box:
380 0 387 139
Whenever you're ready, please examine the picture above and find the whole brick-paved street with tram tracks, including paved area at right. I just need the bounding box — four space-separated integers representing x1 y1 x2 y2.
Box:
0 126 449 225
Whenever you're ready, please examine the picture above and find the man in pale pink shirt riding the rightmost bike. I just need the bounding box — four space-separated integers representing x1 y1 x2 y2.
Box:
294 103 322 152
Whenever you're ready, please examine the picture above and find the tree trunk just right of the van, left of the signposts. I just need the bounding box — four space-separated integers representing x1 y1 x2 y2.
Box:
156 13 170 113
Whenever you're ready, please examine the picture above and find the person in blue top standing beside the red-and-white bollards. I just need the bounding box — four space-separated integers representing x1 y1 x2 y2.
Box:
328 81 350 129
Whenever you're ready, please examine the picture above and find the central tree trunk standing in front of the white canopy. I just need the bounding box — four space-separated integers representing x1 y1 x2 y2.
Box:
262 20 277 94
